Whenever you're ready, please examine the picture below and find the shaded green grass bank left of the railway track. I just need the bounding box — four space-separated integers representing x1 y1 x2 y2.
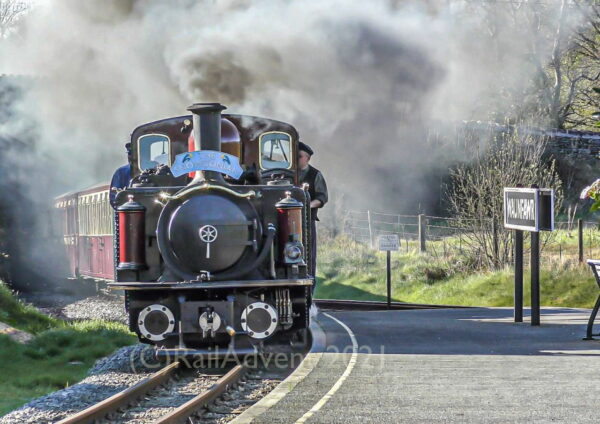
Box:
0 283 136 416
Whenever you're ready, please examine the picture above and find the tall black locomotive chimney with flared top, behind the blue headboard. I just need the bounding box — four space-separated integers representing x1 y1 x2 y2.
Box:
187 103 227 184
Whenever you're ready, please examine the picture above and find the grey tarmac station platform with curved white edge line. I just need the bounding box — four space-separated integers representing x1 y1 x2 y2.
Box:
233 308 600 424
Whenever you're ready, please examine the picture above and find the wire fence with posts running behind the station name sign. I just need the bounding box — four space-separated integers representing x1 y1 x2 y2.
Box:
343 211 600 265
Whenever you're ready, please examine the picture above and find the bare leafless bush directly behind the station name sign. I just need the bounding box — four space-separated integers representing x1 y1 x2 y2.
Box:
448 133 563 268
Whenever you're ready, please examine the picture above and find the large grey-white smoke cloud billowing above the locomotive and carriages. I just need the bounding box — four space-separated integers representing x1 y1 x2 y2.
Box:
0 0 572 229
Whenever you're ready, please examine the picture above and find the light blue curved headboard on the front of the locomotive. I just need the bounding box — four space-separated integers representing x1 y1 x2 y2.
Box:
171 150 244 179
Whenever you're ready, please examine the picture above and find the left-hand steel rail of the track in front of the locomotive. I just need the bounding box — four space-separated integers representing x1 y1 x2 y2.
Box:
58 362 180 424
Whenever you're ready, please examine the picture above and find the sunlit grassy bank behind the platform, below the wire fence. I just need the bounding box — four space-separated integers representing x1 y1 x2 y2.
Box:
316 234 600 308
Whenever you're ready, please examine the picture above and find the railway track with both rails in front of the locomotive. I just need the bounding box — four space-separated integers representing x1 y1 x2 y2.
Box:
58 362 247 424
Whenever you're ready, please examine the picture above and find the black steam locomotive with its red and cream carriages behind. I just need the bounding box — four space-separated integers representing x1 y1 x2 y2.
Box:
56 103 314 356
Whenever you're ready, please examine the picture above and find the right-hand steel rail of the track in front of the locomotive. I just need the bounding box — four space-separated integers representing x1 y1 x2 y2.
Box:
155 365 246 424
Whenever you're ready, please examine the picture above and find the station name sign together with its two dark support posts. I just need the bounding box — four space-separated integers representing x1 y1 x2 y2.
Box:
504 185 554 325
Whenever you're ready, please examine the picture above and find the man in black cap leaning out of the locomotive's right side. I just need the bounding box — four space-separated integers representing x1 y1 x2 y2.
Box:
298 142 327 292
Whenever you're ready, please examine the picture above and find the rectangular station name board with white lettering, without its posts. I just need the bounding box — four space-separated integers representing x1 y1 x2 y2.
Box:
504 188 554 232
